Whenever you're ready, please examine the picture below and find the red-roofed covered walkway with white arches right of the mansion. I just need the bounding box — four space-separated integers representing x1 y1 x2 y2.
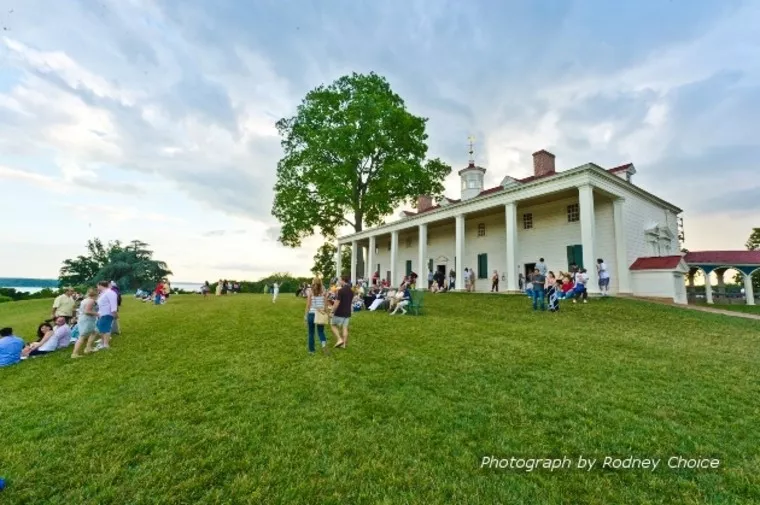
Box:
684 251 760 305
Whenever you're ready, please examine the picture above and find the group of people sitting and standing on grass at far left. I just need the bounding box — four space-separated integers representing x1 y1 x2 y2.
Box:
0 281 121 367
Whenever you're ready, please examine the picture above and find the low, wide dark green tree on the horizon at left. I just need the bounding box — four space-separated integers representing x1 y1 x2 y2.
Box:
58 238 171 290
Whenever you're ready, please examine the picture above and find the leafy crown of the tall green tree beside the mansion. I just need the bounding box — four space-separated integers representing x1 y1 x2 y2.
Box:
272 73 451 247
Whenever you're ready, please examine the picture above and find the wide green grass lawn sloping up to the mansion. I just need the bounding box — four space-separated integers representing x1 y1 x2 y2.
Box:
0 294 760 505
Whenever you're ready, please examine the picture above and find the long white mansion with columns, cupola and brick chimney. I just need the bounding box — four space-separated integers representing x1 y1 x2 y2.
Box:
337 150 688 303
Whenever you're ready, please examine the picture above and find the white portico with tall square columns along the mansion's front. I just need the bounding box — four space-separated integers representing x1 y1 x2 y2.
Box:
336 164 648 294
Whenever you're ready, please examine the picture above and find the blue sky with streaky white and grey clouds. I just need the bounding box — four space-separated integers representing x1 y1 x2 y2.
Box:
0 0 760 281
